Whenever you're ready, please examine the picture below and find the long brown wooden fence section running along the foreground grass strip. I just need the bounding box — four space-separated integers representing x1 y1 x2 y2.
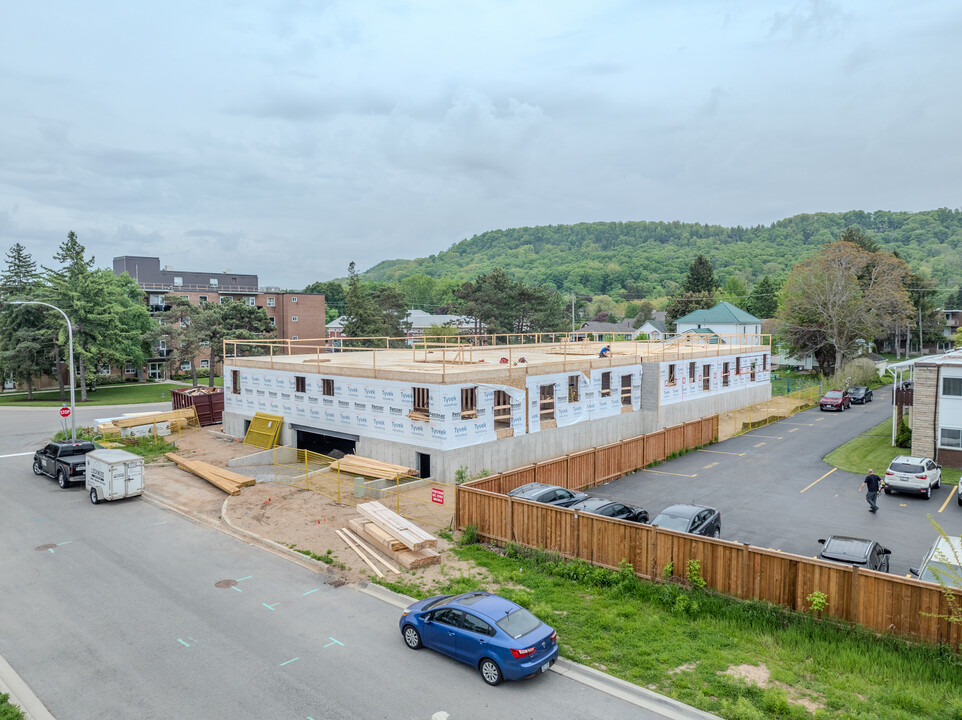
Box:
457 480 962 650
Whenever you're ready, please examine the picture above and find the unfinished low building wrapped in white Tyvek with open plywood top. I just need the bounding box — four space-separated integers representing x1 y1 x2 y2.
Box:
223 333 771 481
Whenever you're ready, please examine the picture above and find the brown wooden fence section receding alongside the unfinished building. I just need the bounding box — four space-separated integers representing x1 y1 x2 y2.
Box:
458 415 718 498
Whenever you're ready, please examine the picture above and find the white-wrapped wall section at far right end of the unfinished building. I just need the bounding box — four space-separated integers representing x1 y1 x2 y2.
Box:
659 351 772 405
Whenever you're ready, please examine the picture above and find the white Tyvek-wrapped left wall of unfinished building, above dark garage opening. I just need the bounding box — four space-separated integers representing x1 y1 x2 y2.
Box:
224 368 525 449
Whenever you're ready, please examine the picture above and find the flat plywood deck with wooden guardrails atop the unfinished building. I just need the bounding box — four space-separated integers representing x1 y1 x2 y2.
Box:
224 335 770 385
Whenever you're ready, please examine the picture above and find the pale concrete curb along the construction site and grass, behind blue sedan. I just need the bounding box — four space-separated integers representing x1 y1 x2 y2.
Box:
144 491 718 720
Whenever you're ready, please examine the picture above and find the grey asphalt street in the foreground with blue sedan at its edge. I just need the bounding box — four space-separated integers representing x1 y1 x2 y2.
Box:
0 406 676 720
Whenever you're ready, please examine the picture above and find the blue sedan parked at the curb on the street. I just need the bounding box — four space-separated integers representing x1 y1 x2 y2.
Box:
399 591 558 685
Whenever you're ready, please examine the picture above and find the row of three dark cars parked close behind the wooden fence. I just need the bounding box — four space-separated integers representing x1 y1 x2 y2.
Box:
508 482 721 538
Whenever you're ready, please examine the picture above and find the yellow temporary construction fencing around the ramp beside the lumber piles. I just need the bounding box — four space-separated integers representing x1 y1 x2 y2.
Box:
273 446 458 528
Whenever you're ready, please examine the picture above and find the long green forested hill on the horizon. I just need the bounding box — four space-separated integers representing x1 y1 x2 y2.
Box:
364 209 962 298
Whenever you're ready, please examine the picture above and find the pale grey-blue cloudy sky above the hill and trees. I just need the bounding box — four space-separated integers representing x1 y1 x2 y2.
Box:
0 0 962 289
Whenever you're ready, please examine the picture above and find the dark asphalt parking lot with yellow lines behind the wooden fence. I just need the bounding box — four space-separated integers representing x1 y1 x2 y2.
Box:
591 400 962 575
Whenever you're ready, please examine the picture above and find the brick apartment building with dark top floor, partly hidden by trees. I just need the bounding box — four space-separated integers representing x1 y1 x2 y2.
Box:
113 255 326 379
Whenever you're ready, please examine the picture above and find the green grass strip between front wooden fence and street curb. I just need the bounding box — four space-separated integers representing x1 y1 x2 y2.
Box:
388 545 962 720
